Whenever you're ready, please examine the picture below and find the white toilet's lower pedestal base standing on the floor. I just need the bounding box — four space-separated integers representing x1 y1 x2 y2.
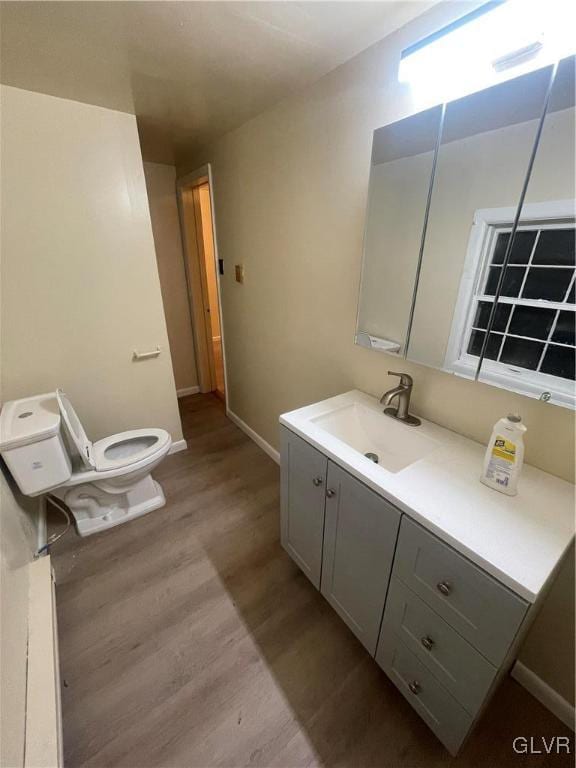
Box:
56 475 166 536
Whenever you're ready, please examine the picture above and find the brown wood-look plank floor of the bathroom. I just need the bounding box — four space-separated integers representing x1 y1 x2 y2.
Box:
52 395 573 768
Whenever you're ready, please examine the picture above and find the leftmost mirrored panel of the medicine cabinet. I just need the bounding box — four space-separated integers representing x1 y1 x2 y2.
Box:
356 107 442 355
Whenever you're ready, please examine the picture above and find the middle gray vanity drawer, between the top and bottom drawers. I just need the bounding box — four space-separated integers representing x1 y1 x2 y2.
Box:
376 579 497 715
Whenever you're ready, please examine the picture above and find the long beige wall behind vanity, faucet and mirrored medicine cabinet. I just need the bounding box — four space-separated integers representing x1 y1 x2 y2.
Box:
179 3 574 700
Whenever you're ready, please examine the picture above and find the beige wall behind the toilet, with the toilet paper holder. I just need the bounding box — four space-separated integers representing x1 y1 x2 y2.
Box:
1 86 182 440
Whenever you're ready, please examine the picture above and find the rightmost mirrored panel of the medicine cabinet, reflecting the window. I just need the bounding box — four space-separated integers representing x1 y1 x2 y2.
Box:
477 59 576 407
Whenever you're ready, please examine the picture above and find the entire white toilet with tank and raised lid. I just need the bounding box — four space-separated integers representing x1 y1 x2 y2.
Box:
0 390 172 536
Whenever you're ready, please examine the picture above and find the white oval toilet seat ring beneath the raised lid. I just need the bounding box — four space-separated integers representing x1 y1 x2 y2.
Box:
92 429 171 472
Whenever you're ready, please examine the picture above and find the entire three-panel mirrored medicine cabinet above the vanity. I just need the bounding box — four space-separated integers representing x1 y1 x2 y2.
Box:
356 57 576 408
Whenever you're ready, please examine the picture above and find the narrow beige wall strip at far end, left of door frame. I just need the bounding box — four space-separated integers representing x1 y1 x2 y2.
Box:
144 163 198 389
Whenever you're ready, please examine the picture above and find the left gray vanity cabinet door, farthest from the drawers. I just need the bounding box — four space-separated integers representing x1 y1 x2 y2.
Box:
280 427 328 589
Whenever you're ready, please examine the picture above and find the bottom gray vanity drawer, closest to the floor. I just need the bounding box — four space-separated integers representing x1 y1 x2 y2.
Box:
376 632 473 755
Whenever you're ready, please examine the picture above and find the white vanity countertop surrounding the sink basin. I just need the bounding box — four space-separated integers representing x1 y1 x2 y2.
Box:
280 390 575 603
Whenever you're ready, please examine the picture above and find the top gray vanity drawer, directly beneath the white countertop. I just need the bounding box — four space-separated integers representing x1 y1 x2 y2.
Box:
394 511 528 666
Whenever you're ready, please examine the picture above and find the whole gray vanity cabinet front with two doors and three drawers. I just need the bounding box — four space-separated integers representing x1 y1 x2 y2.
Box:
281 427 534 754
